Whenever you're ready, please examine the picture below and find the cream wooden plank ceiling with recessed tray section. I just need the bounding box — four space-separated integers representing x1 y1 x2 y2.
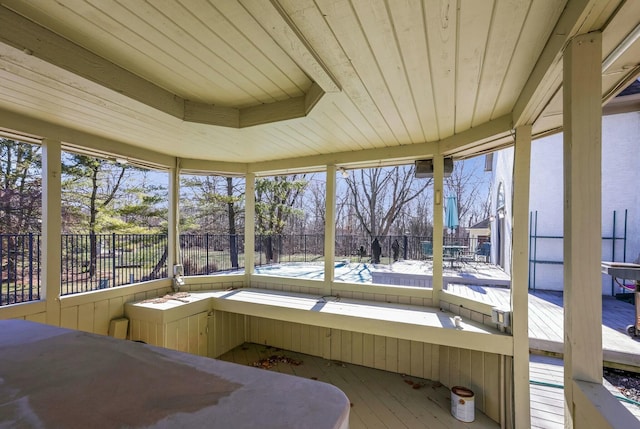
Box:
0 0 640 171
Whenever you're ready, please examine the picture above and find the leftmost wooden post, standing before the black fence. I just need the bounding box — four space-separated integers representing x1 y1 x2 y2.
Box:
41 139 62 326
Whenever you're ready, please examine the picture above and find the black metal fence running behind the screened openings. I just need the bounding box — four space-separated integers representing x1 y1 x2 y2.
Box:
0 233 490 305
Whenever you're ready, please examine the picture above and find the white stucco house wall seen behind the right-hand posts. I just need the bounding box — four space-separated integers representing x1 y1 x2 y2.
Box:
492 112 640 295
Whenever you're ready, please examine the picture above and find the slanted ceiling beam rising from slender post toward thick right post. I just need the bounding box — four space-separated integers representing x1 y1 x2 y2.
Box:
513 0 606 128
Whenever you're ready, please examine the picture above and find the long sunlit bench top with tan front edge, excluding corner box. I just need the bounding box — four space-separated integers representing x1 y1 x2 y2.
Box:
211 288 513 356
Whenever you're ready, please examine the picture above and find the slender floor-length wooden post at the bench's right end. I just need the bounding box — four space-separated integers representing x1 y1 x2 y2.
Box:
507 125 531 428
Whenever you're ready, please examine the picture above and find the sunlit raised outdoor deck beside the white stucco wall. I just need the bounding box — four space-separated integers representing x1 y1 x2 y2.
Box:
448 284 640 372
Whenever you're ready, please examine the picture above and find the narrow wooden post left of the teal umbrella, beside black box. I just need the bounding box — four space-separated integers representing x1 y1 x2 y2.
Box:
432 145 444 307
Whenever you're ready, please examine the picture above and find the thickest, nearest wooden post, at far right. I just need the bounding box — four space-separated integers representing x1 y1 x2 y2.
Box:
563 32 602 428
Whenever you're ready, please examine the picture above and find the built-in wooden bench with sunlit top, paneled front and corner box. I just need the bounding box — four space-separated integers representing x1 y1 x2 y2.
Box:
125 288 513 422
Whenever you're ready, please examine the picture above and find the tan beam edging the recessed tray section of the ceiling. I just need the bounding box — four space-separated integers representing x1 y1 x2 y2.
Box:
0 6 332 128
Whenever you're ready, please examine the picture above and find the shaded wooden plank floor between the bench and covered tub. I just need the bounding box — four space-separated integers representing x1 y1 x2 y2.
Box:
219 344 499 429
